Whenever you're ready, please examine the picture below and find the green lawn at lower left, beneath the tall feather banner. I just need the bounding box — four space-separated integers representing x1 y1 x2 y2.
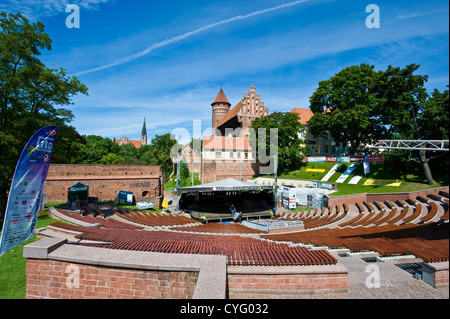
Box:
0 216 57 299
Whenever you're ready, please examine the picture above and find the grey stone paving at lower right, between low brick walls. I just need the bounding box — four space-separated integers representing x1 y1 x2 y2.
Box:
301 252 449 299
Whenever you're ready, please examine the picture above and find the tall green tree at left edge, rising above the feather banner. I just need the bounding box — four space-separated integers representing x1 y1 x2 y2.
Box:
0 12 87 211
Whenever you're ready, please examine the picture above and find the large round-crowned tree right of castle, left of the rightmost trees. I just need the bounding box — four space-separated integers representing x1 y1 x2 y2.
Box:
308 64 385 154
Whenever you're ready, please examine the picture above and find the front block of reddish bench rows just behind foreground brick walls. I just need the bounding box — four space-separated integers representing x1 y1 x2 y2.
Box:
79 230 337 266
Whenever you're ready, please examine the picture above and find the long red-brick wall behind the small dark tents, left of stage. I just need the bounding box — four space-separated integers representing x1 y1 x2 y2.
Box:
44 164 163 208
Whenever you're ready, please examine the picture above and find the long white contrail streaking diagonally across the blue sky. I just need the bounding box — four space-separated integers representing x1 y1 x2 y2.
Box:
75 0 309 75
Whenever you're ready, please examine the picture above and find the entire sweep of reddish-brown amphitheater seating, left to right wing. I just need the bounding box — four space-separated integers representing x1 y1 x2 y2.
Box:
45 194 449 266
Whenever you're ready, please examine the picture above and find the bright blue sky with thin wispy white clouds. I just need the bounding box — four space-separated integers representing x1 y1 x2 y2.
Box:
0 0 449 139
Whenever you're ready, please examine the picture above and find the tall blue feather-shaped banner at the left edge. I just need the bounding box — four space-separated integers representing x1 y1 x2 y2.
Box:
0 126 58 256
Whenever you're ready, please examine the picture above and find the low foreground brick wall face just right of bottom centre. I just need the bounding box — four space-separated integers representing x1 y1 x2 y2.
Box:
228 273 348 299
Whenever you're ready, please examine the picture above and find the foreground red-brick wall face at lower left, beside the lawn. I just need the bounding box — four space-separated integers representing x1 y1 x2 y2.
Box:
26 259 198 299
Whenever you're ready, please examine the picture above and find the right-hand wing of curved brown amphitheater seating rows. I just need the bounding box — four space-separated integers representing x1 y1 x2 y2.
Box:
261 199 449 262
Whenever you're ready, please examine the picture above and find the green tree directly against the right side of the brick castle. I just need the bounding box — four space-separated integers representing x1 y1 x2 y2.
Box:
250 112 305 173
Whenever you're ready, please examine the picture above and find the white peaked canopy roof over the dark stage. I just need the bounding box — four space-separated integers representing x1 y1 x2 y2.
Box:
178 178 273 192
